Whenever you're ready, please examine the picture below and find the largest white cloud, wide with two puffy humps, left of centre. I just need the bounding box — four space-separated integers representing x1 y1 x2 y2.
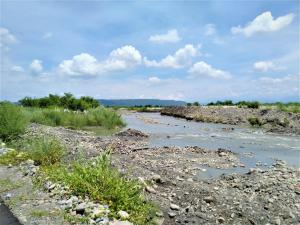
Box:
58 45 142 76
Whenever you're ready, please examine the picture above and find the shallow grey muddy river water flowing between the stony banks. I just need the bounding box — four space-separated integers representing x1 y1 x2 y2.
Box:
123 113 300 178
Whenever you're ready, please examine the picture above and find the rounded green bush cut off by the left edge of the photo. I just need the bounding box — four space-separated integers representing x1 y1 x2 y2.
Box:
0 102 28 141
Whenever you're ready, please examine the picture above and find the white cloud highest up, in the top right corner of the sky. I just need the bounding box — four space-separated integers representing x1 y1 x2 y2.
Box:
231 11 295 37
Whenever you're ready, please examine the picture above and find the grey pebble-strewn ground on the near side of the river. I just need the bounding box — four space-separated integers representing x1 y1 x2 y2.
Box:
0 125 300 225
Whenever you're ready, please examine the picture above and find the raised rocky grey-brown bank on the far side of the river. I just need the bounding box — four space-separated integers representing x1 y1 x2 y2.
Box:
161 106 300 135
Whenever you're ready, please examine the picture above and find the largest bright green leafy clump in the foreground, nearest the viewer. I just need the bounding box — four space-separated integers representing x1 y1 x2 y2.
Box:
43 153 156 224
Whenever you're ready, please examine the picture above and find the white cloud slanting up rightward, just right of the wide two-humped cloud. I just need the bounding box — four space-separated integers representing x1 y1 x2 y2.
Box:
144 44 201 69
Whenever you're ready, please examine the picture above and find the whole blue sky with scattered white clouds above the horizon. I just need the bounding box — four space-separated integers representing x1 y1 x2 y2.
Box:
0 0 300 103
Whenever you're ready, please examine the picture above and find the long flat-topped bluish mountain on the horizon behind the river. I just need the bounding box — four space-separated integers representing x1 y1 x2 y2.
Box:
98 99 186 107
